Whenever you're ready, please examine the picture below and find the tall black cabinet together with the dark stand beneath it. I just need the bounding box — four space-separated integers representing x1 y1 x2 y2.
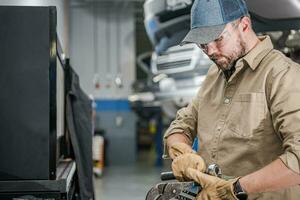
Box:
0 6 87 200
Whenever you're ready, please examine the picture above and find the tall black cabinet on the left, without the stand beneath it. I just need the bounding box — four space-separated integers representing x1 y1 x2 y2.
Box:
0 6 65 180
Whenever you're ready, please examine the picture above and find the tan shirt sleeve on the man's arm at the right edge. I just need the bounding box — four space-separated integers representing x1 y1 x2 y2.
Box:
270 62 300 174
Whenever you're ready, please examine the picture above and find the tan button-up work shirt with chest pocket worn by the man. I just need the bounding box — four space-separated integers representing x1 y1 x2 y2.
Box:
164 36 300 200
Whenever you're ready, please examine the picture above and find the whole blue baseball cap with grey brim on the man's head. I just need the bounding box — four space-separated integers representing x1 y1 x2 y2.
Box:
181 0 248 45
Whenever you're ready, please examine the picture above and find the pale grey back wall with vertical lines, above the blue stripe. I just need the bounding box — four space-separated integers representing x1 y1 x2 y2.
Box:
70 2 135 99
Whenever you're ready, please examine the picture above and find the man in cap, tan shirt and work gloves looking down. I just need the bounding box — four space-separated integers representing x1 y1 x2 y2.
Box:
164 0 300 200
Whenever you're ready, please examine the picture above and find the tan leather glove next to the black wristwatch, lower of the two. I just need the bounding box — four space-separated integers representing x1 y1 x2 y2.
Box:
184 168 239 200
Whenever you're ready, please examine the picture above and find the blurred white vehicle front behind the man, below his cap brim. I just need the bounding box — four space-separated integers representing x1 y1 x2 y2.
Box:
150 44 212 118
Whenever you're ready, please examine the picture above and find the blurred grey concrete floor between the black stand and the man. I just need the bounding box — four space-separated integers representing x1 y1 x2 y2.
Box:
94 153 170 200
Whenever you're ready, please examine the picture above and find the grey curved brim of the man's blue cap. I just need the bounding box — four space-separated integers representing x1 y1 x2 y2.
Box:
180 24 226 45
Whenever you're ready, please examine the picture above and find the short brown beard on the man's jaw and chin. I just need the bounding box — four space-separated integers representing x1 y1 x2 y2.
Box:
209 37 246 71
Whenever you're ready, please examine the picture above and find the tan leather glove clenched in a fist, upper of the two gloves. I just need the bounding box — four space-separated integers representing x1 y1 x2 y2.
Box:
172 153 206 181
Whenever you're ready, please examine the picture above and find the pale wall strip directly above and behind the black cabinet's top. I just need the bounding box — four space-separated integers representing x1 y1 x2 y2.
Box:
0 0 69 56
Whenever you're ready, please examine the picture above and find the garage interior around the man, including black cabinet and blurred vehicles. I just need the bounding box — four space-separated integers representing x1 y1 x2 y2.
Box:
0 0 300 200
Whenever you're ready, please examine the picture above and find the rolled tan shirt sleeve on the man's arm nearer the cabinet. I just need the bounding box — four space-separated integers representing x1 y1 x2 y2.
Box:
163 91 200 159
